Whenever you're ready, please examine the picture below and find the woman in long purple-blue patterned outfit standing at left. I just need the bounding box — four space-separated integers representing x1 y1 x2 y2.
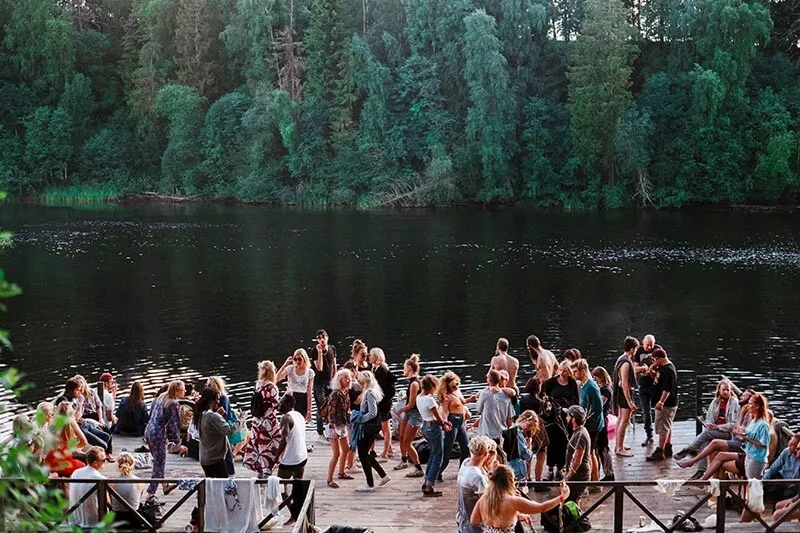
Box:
144 380 186 499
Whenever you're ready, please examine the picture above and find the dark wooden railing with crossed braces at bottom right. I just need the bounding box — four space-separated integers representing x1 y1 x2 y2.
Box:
519 479 800 533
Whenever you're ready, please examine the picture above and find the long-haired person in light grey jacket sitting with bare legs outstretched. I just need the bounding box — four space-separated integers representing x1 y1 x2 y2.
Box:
675 379 740 480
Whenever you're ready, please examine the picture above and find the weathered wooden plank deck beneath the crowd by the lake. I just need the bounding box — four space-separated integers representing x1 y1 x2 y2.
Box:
104 421 800 533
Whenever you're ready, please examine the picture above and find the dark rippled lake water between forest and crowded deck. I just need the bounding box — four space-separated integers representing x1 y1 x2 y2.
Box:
0 206 800 428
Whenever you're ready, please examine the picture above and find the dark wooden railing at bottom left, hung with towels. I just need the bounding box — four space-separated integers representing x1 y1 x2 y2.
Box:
0 478 315 533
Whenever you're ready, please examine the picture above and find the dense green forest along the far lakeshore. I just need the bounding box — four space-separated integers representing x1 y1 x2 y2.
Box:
0 0 800 209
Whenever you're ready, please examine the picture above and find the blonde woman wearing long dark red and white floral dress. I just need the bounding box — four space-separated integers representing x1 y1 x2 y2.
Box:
244 361 281 478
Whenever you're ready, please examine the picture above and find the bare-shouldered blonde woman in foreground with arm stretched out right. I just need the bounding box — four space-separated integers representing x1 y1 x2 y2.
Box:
470 465 569 533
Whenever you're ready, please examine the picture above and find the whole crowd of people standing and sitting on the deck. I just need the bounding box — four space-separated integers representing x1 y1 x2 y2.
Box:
6 330 800 533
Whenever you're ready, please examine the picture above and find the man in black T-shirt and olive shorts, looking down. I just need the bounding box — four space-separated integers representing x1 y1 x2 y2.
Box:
647 348 678 461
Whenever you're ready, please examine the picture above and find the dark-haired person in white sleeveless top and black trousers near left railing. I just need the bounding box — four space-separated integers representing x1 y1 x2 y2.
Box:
278 394 308 520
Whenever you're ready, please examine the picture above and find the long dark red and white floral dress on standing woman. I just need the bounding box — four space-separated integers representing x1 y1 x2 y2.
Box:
244 381 281 477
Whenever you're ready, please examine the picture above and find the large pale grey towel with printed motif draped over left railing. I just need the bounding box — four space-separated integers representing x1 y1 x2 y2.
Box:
205 478 264 533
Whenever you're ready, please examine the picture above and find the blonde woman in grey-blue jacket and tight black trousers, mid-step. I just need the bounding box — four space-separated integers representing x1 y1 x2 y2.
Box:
355 370 391 492
